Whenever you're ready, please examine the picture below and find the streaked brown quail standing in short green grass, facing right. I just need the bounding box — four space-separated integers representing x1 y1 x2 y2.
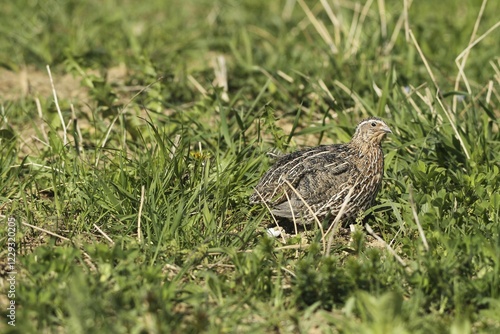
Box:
250 117 392 225
